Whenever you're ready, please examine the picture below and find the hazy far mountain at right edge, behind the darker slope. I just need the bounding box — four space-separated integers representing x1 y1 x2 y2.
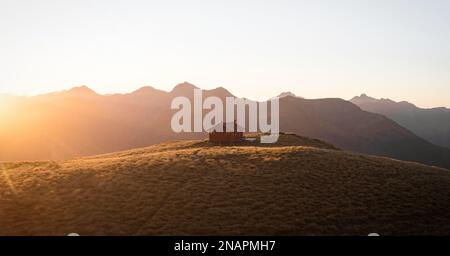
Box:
351 94 450 148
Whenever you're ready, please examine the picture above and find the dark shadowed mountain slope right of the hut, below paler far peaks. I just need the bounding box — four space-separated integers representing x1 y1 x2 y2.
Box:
280 97 450 169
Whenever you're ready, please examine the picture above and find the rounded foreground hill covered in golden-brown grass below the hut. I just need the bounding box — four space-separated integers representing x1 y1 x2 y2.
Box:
0 135 450 235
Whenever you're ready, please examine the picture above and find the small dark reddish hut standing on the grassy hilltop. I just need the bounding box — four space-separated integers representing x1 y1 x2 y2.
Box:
209 121 244 144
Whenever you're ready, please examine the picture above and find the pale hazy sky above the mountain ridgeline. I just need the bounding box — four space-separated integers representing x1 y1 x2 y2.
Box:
0 0 450 107
